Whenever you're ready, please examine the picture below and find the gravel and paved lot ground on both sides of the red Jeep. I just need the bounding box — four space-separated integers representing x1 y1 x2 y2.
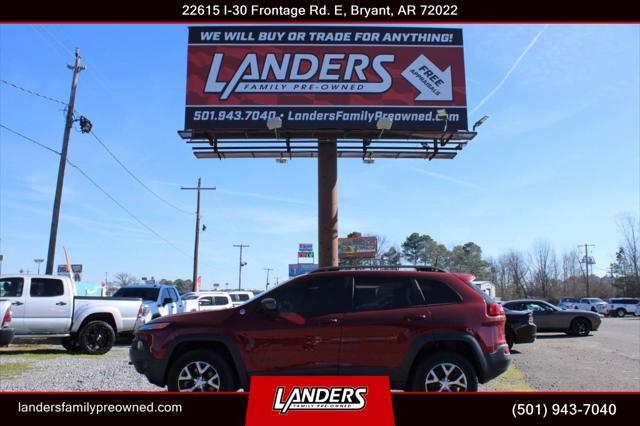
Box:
0 317 640 391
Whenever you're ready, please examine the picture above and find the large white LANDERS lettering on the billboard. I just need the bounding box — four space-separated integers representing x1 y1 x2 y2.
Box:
204 53 395 100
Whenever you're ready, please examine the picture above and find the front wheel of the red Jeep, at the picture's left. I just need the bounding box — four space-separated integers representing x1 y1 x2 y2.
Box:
167 350 238 392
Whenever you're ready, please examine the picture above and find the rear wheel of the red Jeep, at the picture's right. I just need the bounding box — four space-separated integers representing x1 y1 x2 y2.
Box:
410 352 478 392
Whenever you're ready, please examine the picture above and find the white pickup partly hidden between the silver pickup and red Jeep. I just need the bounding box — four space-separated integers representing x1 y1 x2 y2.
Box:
113 284 198 323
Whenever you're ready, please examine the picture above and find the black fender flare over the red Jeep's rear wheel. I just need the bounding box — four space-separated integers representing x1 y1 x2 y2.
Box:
401 333 489 383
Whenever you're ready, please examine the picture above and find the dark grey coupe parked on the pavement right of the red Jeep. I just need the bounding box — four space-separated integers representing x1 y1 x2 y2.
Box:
503 299 602 336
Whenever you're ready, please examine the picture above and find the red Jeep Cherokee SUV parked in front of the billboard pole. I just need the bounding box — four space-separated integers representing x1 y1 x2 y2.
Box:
130 267 511 391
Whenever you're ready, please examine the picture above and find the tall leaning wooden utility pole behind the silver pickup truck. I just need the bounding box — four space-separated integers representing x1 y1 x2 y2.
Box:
46 49 86 275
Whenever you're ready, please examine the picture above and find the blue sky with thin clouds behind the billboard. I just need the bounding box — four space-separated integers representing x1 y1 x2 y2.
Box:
0 25 640 288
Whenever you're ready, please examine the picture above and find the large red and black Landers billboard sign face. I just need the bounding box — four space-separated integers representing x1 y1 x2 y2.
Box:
185 25 468 131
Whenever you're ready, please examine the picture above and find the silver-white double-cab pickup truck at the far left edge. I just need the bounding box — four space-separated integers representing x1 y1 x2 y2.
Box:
0 275 143 354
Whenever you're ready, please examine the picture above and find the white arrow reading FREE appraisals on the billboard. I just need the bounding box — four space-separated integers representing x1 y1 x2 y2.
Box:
402 55 453 101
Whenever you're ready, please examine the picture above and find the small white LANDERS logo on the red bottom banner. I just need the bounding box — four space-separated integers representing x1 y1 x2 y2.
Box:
273 386 368 414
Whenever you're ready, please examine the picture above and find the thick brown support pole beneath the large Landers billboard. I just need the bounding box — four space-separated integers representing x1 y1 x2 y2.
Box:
318 139 338 267
